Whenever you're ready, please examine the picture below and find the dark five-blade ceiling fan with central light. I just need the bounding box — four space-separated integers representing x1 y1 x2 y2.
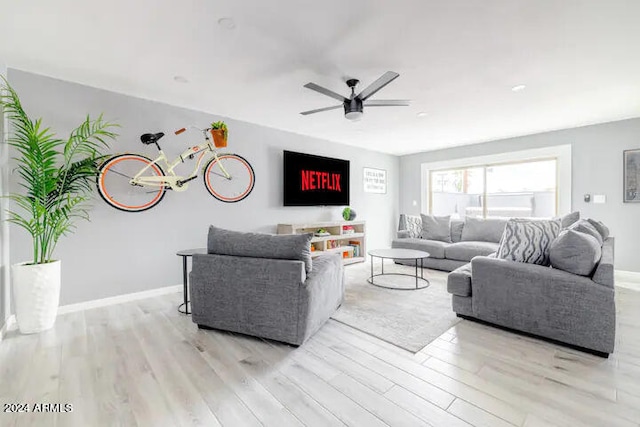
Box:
300 71 409 120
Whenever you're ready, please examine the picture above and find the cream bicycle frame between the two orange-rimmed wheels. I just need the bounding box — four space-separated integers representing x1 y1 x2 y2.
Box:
129 129 231 191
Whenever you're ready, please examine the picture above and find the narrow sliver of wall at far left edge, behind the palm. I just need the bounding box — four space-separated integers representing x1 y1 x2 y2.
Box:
0 62 10 329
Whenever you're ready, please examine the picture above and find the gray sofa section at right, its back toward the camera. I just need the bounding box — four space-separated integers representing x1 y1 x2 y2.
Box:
447 219 616 357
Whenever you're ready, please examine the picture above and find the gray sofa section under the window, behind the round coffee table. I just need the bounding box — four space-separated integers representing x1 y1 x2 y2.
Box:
391 214 506 271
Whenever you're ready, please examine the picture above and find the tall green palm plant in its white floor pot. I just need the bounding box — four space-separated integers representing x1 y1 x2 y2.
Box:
0 78 117 334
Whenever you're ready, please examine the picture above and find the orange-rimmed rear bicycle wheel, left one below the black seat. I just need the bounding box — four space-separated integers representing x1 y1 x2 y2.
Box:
96 154 166 212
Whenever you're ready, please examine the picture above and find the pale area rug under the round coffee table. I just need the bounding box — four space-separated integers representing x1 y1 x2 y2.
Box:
332 261 459 353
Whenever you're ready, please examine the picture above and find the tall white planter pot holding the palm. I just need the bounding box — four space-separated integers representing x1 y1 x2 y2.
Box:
11 261 61 334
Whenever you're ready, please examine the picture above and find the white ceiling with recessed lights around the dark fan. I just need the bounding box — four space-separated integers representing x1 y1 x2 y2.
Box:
0 0 640 154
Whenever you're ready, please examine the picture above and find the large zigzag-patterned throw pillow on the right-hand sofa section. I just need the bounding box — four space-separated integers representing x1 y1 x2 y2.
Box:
497 218 562 266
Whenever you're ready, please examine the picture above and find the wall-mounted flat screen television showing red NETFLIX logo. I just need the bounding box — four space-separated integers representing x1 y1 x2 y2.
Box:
283 150 349 206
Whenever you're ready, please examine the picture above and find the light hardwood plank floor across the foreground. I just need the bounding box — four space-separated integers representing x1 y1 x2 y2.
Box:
0 280 640 427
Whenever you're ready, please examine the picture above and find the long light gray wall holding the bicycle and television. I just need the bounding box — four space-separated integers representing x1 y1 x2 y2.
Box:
9 69 399 305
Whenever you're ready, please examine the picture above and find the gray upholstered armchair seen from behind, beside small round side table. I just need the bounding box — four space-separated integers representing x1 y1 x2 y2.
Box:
190 227 344 345
